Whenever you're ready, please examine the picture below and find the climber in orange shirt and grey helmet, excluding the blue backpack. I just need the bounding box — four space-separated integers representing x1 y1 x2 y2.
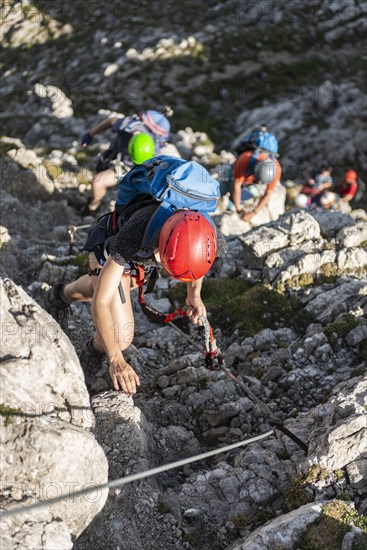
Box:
232 151 282 222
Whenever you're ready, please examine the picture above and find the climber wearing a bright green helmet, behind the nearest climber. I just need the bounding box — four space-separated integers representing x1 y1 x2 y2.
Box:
81 107 172 215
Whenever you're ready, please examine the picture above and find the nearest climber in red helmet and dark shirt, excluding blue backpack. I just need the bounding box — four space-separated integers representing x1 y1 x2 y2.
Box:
49 157 226 395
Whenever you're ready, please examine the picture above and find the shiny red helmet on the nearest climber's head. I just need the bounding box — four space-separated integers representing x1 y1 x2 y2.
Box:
159 210 217 282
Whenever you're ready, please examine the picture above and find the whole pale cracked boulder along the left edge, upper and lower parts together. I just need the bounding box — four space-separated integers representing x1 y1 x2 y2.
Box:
0 279 107 550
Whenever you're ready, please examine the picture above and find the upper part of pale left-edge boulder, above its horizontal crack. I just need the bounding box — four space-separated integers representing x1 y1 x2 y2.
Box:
0 279 94 428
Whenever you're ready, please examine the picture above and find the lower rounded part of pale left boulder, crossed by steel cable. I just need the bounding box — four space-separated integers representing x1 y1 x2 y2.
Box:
0 418 107 540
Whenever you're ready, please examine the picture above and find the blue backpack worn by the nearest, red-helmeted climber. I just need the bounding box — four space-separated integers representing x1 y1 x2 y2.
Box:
116 155 220 250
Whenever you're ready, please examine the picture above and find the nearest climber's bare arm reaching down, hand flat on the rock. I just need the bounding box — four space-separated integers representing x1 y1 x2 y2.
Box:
92 257 140 395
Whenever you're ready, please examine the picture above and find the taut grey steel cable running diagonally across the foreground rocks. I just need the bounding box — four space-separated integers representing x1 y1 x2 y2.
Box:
0 430 274 519
